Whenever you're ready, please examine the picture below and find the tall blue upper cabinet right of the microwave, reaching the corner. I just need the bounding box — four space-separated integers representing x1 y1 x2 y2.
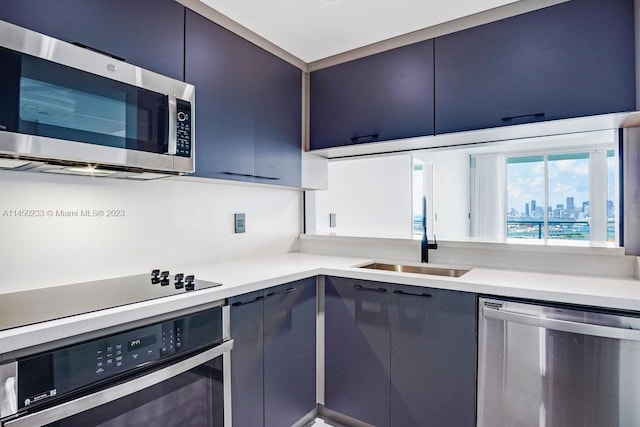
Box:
185 10 302 186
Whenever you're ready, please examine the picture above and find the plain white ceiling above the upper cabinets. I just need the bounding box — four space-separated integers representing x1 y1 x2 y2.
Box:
201 0 518 63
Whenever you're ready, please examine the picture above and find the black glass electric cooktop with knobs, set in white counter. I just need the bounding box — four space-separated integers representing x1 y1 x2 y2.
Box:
0 270 221 331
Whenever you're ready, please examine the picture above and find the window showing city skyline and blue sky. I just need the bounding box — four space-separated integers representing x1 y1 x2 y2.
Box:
506 150 617 242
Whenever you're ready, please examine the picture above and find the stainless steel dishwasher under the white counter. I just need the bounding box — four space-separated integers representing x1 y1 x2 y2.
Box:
478 298 640 427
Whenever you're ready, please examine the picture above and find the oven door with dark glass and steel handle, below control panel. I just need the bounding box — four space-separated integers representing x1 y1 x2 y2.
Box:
2 340 233 427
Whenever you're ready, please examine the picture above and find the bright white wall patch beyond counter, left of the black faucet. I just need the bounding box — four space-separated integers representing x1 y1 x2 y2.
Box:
307 154 412 238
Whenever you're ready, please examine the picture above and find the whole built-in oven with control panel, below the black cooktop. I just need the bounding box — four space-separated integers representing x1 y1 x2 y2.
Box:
0 302 233 427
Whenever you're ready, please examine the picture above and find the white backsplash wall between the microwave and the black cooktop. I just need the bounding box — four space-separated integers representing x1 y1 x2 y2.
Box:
0 171 302 293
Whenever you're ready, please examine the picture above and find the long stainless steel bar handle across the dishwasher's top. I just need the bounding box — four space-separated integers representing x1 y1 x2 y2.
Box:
482 307 640 341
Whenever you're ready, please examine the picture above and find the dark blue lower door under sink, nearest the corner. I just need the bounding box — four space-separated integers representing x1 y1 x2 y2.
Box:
325 277 390 427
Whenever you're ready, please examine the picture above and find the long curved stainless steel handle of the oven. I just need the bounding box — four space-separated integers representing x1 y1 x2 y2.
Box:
5 340 233 427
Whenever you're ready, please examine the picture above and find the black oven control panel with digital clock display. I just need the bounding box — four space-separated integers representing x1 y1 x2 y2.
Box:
18 307 224 408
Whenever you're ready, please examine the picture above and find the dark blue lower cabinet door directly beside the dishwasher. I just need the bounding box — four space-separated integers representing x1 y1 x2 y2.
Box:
390 285 476 427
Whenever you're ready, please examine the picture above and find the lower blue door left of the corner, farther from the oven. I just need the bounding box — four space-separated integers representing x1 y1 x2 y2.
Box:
262 278 316 427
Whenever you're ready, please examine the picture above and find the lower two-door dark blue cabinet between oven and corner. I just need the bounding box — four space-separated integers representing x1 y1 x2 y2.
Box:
229 278 316 427
